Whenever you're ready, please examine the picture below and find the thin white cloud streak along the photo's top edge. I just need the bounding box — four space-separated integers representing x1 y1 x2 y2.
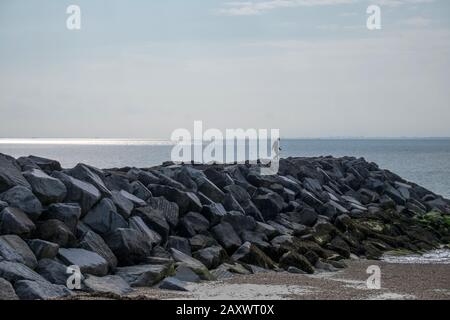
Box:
217 0 435 16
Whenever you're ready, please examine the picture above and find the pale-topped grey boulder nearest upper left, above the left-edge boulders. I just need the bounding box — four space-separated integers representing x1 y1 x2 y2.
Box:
23 169 67 204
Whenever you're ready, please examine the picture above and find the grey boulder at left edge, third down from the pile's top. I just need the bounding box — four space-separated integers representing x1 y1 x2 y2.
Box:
0 208 36 237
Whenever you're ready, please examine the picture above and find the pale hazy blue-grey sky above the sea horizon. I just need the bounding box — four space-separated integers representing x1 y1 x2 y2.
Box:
0 0 450 139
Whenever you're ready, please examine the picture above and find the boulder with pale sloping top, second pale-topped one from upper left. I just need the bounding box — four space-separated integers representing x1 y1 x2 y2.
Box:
52 171 101 214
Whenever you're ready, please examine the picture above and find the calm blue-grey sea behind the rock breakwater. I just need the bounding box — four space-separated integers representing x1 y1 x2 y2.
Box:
0 139 450 198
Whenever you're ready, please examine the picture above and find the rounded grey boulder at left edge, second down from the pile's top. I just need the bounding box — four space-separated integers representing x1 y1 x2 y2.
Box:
0 186 42 221
